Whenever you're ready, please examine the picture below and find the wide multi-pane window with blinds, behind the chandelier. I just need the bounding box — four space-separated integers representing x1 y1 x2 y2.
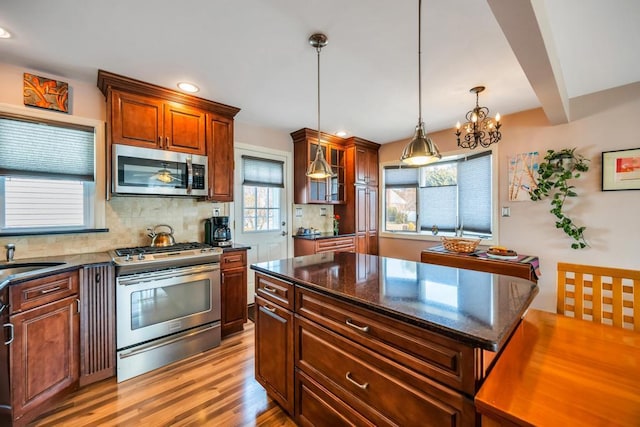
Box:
383 150 497 240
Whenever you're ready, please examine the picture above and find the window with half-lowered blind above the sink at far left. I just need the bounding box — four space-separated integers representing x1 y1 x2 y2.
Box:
0 106 104 235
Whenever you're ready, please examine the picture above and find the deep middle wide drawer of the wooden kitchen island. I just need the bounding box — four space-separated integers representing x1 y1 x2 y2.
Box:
295 316 476 427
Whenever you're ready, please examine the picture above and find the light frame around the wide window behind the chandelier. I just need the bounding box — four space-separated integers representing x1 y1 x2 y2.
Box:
379 145 500 246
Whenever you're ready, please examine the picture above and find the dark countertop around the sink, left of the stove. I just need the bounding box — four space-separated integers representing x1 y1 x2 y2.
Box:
0 252 111 290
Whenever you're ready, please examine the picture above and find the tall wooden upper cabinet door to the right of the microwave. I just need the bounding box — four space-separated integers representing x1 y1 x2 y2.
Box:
207 114 234 202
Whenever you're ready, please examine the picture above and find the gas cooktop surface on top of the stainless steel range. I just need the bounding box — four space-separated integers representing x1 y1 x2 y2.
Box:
110 242 222 274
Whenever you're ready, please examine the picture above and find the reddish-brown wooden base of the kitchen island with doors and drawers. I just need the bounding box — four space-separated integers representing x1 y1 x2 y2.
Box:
256 273 482 427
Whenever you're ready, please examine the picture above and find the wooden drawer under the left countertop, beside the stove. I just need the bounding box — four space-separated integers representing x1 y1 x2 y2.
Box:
9 270 78 313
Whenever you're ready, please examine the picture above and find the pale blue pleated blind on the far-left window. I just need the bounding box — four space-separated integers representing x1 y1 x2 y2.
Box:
0 115 95 181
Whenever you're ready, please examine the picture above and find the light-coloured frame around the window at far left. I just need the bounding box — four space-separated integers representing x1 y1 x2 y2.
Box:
0 103 109 237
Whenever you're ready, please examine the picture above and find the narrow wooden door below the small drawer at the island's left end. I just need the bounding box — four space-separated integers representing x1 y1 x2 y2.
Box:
255 296 294 416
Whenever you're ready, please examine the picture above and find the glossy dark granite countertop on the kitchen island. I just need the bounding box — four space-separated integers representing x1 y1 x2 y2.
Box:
251 252 538 351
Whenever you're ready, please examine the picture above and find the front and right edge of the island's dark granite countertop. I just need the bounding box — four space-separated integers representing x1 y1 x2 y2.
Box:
250 264 539 352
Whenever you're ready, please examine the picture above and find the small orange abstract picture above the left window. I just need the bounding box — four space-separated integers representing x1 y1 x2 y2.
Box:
23 73 69 113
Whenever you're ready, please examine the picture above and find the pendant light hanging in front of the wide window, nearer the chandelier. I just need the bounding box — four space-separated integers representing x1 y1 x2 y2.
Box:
400 0 442 166
